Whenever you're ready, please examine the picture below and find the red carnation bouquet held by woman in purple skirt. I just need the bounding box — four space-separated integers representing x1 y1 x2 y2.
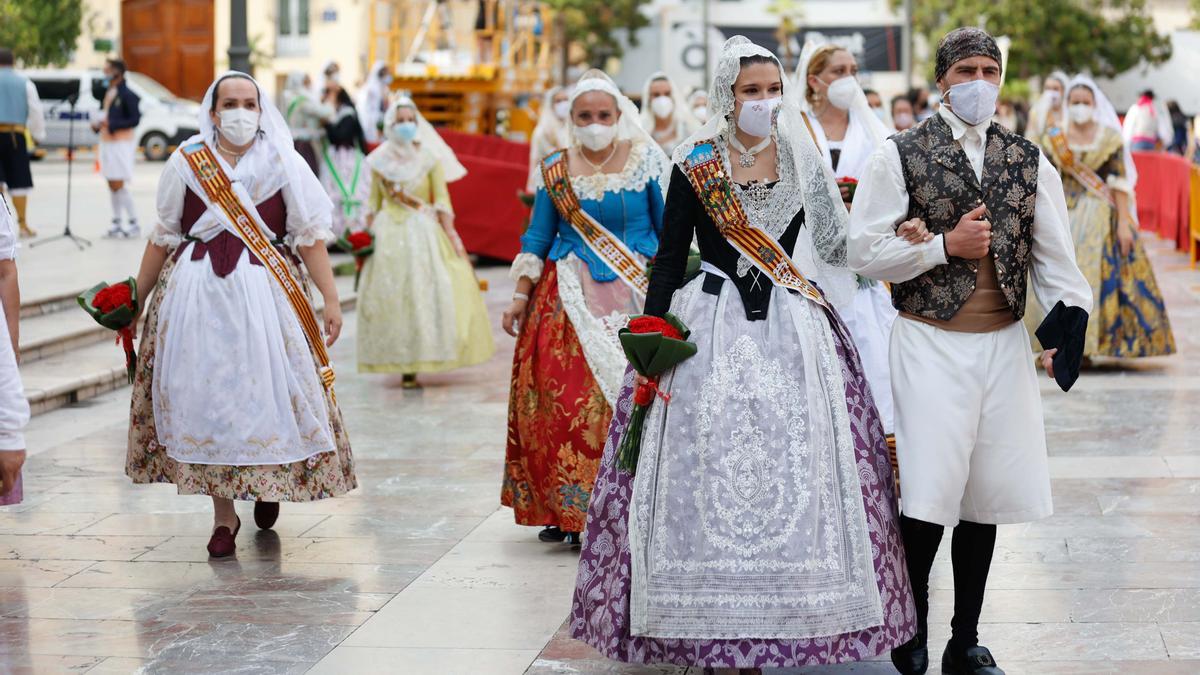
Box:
617 313 696 473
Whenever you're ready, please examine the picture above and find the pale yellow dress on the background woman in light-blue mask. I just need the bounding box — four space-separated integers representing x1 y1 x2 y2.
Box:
356 156 496 374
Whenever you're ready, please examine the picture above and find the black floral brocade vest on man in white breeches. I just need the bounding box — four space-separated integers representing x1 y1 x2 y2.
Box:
892 114 1040 321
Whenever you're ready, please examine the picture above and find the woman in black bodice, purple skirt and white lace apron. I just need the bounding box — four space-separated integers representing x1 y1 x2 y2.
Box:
571 36 919 668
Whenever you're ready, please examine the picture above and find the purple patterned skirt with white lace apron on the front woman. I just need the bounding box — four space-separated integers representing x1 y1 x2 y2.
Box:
570 280 916 668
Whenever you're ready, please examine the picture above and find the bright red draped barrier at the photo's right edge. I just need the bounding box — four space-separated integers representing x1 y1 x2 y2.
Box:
1133 153 1192 251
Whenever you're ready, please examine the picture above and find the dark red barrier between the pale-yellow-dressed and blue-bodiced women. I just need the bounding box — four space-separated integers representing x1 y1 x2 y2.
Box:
438 129 529 261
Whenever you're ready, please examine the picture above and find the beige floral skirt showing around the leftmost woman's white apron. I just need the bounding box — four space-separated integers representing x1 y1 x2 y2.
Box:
125 256 358 502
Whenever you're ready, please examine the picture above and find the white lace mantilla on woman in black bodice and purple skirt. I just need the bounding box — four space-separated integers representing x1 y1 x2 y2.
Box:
672 35 858 311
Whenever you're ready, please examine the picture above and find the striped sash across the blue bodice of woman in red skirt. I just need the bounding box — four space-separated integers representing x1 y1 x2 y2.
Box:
541 150 649 295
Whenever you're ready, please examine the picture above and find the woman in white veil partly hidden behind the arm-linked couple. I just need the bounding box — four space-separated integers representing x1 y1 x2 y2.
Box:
797 42 896 434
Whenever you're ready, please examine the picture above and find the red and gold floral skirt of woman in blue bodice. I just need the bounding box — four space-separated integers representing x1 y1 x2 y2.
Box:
500 262 612 532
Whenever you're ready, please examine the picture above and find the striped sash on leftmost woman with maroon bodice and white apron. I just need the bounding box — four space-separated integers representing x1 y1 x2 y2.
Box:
184 143 334 396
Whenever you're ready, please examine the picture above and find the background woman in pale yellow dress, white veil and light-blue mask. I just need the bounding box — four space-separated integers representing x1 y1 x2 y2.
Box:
358 96 496 388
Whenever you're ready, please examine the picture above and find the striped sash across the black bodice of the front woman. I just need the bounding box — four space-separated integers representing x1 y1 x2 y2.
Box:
683 142 828 307
